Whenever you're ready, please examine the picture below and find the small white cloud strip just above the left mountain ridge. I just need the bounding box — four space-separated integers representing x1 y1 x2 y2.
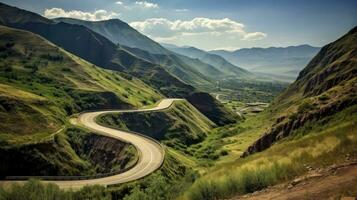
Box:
44 8 119 21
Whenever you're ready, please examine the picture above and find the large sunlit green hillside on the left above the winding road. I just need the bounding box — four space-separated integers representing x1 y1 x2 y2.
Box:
0 27 162 138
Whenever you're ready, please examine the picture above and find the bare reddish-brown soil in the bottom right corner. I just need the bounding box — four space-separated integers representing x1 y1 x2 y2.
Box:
233 162 357 200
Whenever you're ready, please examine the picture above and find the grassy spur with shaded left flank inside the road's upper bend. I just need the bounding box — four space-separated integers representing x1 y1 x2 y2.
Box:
98 100 215 150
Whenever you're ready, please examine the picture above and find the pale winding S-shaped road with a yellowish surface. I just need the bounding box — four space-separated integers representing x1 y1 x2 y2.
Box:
0 99 181 189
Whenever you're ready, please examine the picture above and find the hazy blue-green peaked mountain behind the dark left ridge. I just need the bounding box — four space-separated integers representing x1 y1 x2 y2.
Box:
55 18 251 87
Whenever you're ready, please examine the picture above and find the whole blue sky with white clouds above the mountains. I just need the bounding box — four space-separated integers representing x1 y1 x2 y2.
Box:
0 0 357 50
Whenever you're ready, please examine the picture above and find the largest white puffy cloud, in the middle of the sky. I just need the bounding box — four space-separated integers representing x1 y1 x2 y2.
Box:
130 17 267 42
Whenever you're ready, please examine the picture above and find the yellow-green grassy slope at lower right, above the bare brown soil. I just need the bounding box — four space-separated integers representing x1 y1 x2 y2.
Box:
182 106 357 199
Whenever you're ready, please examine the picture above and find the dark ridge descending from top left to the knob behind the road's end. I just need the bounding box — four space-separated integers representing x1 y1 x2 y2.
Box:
0 3 234 125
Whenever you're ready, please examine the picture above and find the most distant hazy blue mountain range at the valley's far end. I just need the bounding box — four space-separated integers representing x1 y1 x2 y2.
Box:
210 45 320 81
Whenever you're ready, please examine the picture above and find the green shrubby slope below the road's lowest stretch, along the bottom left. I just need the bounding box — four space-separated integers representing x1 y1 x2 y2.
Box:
0 149 196 200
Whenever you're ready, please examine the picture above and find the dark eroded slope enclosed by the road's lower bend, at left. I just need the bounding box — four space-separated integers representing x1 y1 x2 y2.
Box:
0 129 136 179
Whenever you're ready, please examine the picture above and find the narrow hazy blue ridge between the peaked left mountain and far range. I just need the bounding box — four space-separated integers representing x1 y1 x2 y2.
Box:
164 45 253 78
